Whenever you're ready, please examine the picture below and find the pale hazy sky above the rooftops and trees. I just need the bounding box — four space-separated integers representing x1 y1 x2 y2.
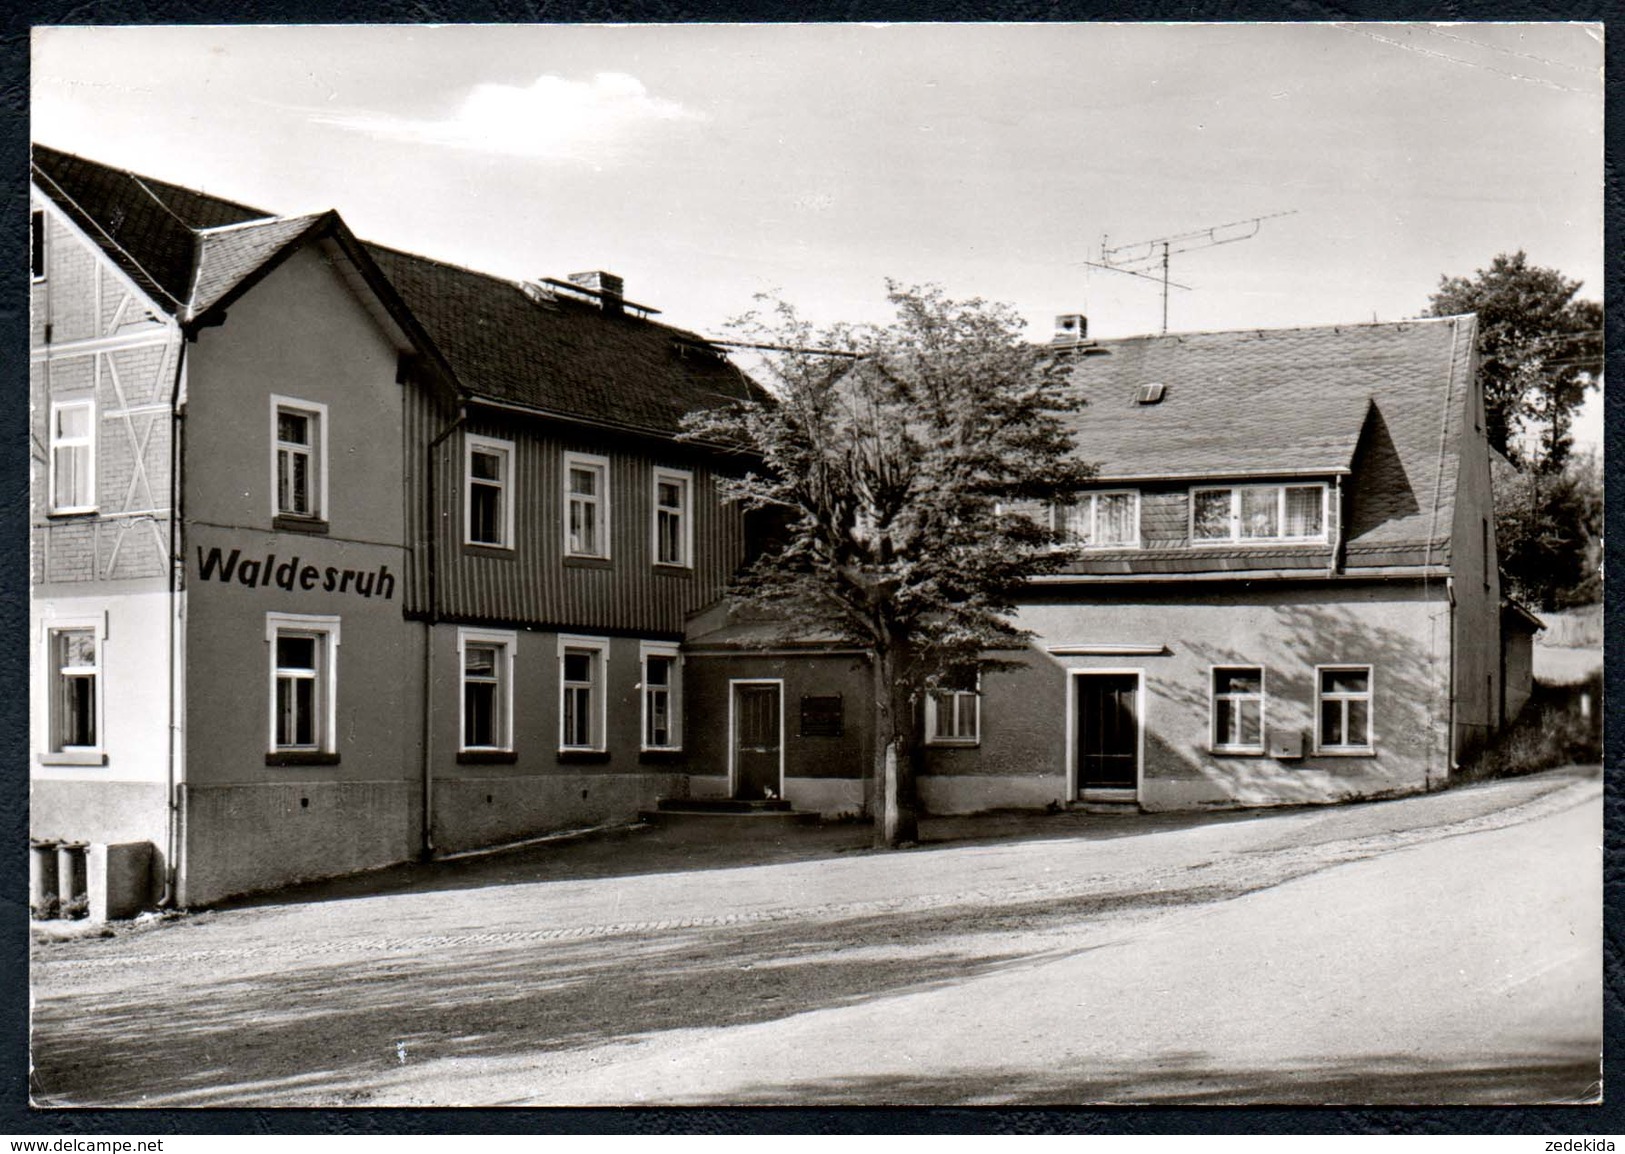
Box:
31 23 1602 442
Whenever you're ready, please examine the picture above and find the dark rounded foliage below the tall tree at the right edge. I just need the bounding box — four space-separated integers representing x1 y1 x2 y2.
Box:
1495 453 1602 610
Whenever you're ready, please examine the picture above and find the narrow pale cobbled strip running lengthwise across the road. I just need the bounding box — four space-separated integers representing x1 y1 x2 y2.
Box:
34 780 1602 982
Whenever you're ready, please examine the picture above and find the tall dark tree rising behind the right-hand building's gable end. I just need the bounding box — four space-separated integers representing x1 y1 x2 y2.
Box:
1427 250 1602 471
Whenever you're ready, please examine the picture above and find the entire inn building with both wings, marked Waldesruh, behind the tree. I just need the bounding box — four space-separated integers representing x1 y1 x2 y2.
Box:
29 146 1529 905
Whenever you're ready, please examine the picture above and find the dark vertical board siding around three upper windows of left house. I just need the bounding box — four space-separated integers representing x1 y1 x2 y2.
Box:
406 387 744 639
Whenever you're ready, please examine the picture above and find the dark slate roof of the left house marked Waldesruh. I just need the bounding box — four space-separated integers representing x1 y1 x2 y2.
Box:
34 145 761 436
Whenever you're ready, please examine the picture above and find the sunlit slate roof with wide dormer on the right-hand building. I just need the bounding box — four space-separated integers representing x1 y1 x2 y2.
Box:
1069 317 1476 572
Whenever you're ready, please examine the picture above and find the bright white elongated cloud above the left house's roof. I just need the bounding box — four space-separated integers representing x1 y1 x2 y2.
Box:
312 72 702 159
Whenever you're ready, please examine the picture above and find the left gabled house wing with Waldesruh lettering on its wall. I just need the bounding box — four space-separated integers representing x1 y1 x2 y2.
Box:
31 146 756 905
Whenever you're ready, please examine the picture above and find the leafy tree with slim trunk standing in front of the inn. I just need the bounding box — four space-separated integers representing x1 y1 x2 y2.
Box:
687 281 1089 845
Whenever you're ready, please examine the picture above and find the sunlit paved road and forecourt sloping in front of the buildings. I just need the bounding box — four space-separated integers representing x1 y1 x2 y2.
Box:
34 770 1602 1105
